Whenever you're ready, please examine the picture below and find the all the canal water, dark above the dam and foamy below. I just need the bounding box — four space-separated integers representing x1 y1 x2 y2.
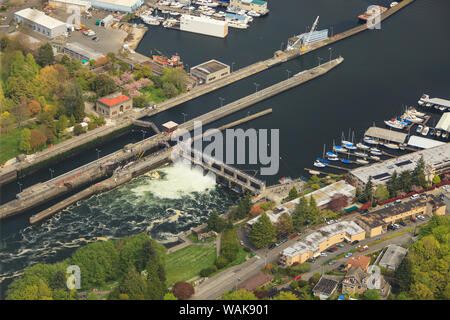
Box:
0 0 450 296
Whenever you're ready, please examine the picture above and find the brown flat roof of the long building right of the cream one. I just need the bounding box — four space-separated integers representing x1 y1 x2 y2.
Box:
357 198 427 228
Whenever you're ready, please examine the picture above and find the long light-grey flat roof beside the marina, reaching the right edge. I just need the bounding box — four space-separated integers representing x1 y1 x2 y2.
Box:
350 143 450 184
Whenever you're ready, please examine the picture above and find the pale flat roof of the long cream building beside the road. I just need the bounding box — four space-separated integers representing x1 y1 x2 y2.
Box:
283 221 365 258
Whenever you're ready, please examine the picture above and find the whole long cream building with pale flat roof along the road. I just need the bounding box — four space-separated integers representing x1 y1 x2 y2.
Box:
279 221 366 267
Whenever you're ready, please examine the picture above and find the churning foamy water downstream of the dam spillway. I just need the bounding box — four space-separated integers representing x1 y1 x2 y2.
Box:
0 164 237 288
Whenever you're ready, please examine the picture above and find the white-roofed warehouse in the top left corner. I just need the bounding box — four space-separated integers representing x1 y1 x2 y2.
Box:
14 8 67 38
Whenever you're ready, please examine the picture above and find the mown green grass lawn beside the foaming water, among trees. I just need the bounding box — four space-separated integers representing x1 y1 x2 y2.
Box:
166 245 216 285
